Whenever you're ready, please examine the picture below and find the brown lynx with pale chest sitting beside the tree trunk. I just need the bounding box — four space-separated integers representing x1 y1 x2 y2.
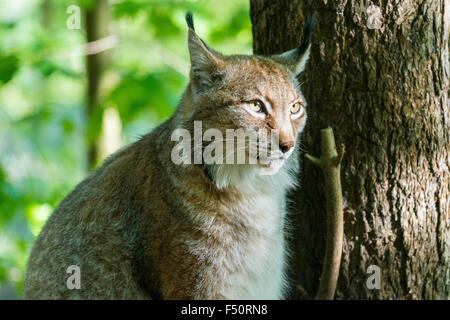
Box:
24 13 314 299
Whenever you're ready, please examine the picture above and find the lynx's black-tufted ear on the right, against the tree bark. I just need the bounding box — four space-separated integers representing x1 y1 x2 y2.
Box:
272 14 315 75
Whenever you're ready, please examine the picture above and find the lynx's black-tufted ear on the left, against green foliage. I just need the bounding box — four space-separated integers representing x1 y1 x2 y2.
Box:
186 12 222 86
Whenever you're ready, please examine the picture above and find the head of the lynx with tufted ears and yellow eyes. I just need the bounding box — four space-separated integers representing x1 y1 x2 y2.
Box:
181 13 314 187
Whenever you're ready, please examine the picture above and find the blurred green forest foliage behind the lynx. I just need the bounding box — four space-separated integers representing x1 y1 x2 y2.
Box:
0 0 252 299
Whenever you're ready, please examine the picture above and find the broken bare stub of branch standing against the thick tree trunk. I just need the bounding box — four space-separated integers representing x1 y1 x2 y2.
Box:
305 127 345 300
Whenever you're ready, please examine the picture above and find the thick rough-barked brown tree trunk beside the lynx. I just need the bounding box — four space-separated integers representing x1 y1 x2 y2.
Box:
251 0 450 299
